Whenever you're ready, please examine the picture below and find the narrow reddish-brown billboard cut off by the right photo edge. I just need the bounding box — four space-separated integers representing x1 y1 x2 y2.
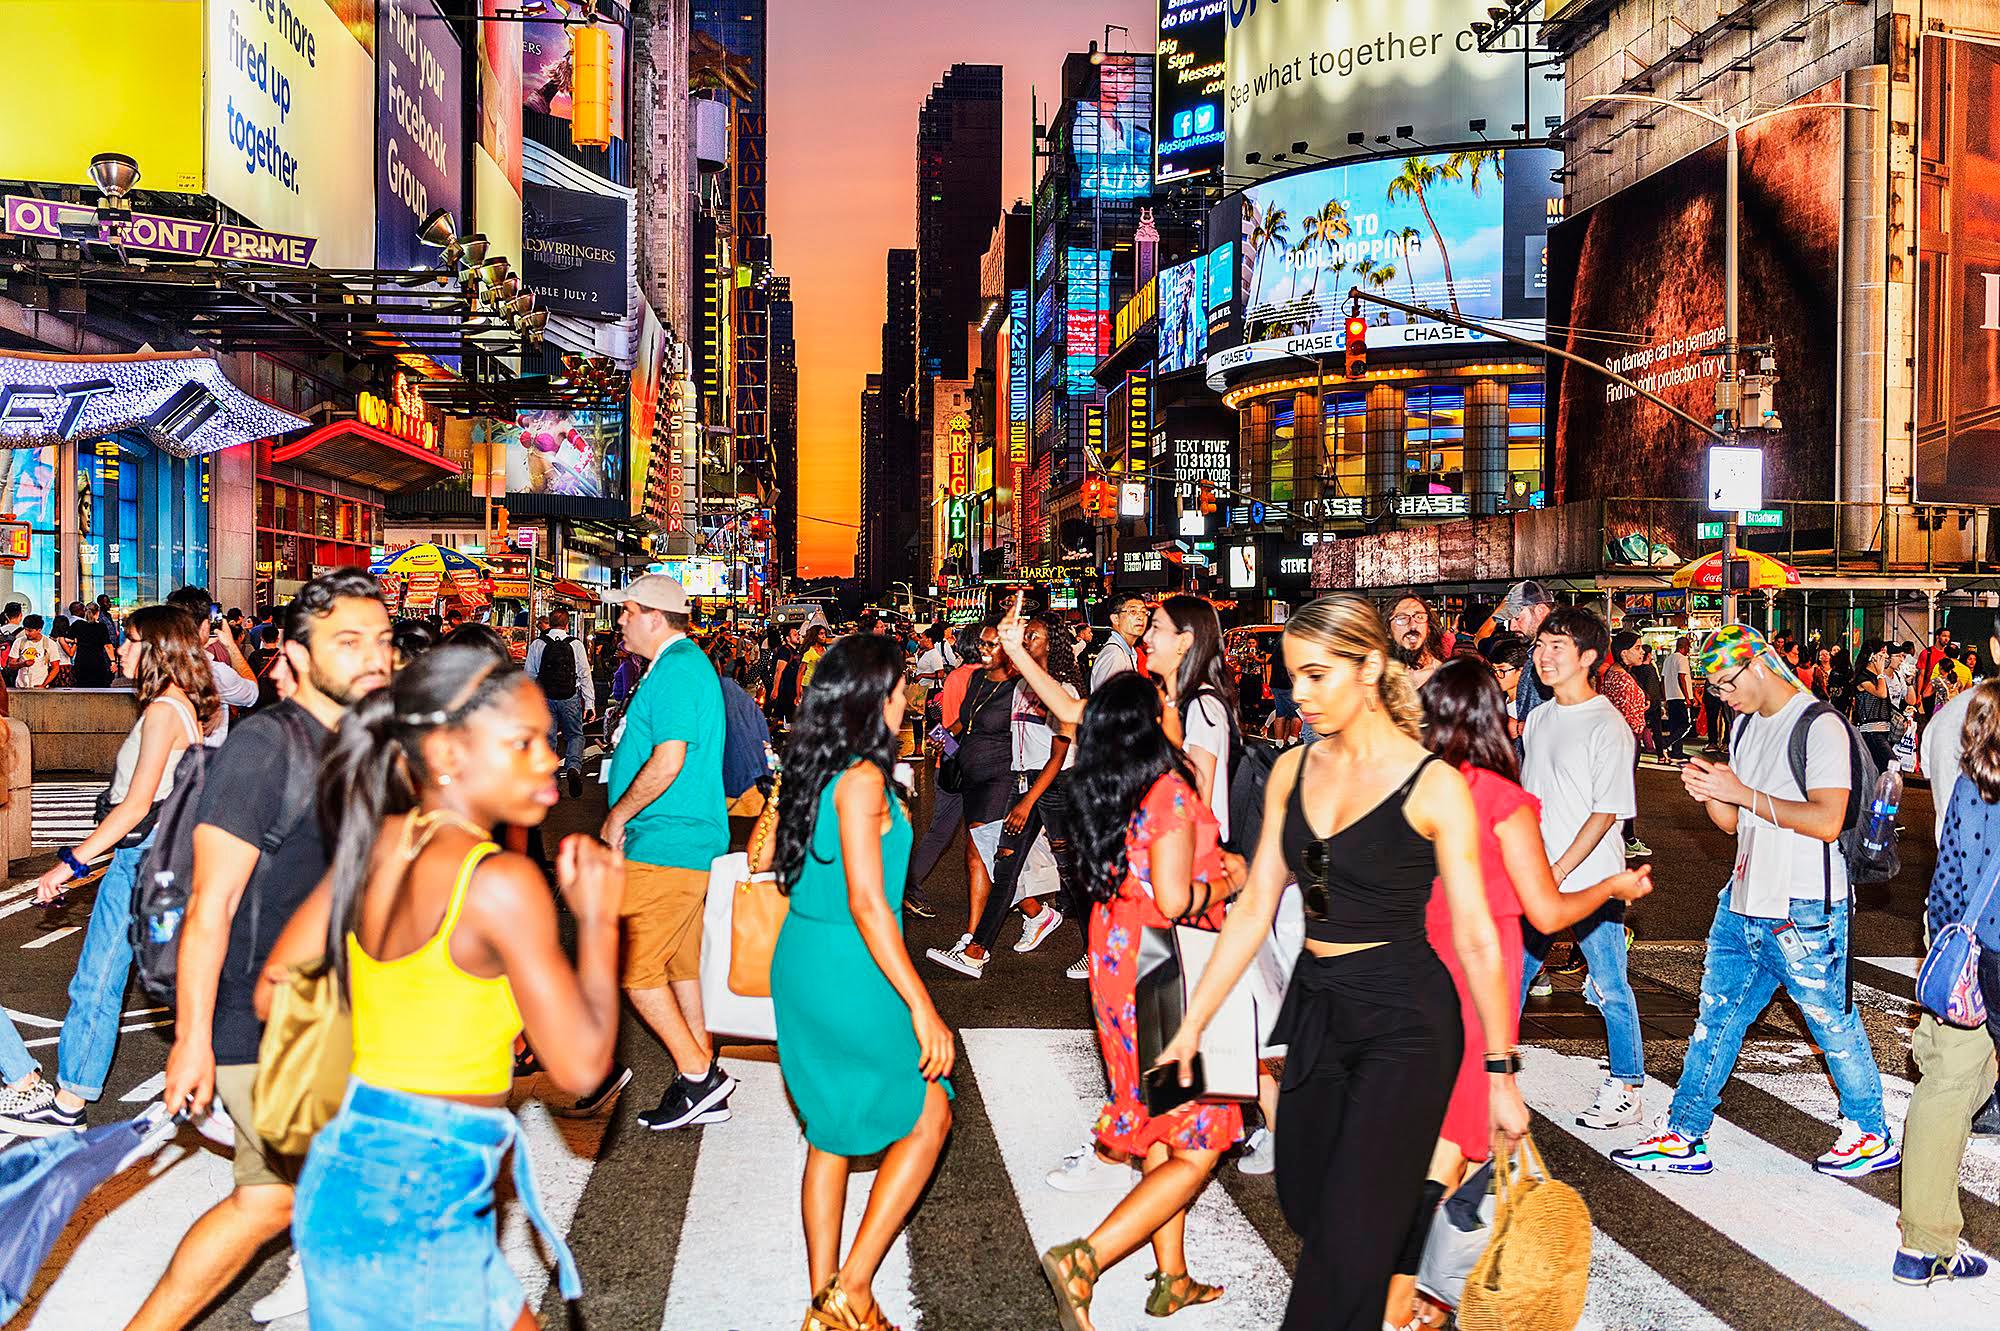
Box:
1916 34 2000 504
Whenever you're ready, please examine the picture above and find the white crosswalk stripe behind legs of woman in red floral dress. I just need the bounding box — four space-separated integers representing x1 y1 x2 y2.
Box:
960 1029 1292 1331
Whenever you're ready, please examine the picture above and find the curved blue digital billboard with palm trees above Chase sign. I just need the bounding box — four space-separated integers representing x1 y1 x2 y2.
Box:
1240 150 1558 344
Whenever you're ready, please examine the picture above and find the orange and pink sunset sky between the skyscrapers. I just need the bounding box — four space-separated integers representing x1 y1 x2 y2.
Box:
768 0 1156 578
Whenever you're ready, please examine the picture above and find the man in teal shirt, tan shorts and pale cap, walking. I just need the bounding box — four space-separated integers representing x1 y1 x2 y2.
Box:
604 574 736 1131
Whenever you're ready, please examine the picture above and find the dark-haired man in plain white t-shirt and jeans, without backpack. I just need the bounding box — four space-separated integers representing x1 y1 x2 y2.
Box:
1520 606 1646 1127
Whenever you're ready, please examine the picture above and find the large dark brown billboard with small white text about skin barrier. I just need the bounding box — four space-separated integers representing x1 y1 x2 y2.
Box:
1548 82 1846 507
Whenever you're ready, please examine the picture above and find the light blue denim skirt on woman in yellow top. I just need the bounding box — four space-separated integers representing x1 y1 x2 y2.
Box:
292 1081 582 1331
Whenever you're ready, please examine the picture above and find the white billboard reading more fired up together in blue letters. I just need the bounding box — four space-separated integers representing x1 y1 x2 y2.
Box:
204 0 376 268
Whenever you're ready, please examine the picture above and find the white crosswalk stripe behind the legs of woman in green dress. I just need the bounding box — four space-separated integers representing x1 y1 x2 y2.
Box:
660 1061 918 1331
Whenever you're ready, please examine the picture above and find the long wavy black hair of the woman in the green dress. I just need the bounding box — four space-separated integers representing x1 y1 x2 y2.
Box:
772 634 902 891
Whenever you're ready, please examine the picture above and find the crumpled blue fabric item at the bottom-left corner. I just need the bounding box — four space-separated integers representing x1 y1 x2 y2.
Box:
0 1105 174 1323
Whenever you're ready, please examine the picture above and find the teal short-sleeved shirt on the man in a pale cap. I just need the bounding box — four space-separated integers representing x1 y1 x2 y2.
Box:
610 638 730 869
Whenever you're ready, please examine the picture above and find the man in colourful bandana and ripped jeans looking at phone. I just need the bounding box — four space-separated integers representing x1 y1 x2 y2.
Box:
1612 624 1902 1179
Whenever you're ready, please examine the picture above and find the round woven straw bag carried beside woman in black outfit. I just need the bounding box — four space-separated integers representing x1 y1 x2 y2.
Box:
1458 1137 1590 1331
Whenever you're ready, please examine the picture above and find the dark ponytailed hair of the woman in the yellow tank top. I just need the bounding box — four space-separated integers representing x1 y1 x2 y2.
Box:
320 646 526 995
